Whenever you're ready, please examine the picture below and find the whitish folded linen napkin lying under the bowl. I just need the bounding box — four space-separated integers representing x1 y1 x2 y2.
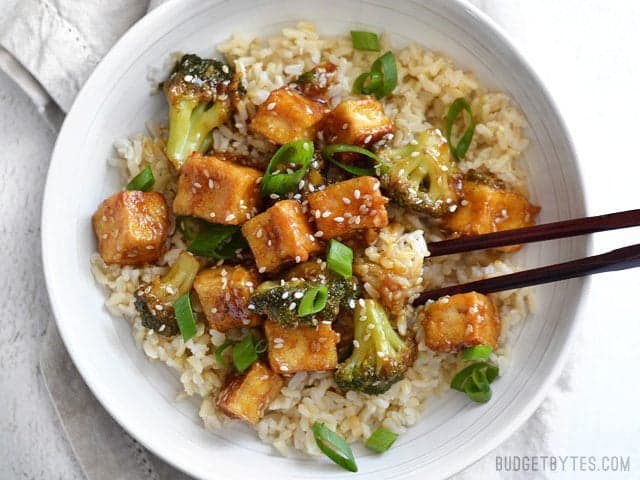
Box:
0 0 569 480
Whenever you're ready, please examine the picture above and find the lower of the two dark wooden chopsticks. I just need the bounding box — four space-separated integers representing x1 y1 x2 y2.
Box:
413 244 640 306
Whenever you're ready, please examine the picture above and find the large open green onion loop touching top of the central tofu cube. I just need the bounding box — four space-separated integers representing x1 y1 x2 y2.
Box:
260 140 313 196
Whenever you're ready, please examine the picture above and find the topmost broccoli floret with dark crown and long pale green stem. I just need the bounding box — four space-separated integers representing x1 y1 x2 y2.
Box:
163 54 242 169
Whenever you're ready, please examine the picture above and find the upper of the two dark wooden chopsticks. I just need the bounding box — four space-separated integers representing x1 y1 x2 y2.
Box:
428 209 640 257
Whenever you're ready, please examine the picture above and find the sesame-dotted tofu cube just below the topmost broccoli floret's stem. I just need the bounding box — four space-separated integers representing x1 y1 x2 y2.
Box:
173 153 262 225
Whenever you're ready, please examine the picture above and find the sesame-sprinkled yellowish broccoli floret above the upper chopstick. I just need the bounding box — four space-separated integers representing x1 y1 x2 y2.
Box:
378 129 461 217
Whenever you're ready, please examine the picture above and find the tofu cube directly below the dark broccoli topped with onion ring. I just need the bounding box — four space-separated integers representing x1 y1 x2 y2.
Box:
264 320 340 374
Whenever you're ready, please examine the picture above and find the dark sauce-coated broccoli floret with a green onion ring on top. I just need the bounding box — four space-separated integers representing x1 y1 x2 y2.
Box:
249 262 360 327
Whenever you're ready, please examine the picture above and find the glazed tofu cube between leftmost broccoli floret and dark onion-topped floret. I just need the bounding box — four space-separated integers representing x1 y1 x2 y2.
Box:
193 265 262 332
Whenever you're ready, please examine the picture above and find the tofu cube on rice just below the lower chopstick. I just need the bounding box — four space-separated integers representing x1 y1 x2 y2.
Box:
420 292 500 352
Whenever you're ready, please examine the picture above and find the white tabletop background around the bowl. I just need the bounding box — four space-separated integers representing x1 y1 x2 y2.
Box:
0 0 640 480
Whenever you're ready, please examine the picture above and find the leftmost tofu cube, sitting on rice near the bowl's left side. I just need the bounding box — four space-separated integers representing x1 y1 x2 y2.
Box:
93 190 169 265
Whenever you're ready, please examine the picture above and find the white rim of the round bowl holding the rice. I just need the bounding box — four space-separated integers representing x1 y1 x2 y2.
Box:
41 0 593 476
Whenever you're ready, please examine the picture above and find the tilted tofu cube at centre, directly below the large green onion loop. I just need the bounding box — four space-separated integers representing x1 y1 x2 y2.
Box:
242 200 322 273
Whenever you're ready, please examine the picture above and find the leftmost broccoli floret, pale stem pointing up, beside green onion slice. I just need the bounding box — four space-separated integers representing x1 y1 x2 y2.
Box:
135 252 200 337
